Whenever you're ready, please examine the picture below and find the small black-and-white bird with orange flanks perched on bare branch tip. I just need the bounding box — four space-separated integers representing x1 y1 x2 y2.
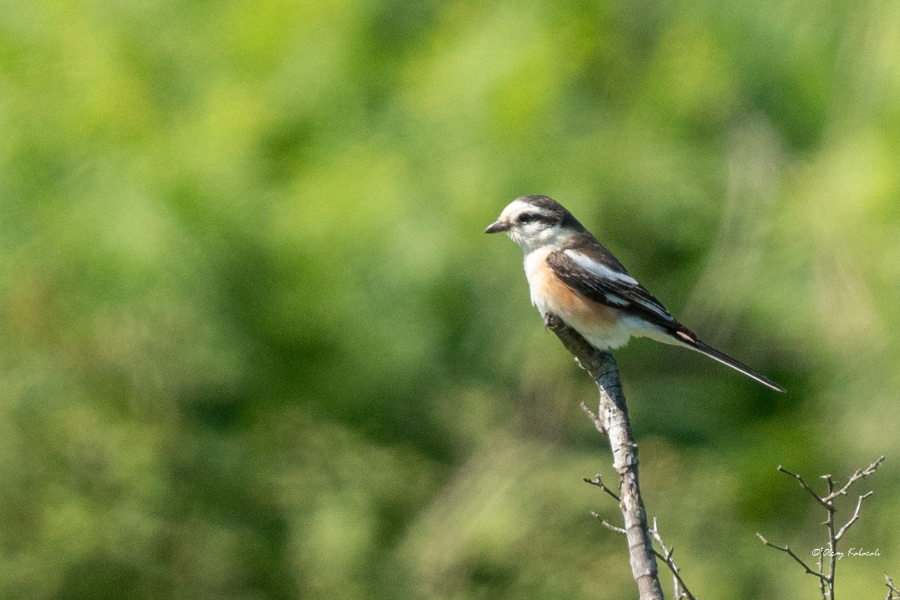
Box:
485 195 785 392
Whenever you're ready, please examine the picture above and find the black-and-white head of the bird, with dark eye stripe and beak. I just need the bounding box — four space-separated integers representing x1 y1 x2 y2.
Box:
484 196 585 254
